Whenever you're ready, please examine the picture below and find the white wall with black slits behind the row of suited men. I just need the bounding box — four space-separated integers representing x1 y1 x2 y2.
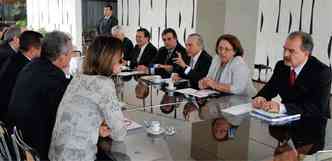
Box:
118 0 197 47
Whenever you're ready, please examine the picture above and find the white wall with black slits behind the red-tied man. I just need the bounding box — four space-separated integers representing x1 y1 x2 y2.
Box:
255 0 332 72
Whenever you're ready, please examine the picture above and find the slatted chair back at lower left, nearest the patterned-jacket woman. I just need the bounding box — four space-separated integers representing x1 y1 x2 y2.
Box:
11 127 40 161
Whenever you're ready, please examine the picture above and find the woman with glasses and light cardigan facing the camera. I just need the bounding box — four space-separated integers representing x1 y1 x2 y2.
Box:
199 35 256 96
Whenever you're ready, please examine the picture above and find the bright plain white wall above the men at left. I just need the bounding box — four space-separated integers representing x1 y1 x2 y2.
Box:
27 0 82 50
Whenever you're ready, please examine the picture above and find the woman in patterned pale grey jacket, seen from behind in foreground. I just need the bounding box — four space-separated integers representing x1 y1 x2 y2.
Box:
49 36 127 161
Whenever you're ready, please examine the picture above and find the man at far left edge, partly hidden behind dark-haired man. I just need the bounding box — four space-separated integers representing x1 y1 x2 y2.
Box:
0 27 21 69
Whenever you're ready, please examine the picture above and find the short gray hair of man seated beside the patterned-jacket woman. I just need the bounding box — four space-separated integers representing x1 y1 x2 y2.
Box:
41 31 72 61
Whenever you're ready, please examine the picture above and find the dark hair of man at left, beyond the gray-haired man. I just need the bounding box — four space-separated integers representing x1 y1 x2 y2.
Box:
20 31 43 52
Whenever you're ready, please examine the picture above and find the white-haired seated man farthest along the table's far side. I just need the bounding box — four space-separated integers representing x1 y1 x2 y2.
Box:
112 25 134 60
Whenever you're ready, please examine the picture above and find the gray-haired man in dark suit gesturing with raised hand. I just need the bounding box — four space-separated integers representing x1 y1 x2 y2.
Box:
172 33 212 89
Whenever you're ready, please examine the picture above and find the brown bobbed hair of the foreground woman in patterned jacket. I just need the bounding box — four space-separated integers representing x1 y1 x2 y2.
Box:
83 35 123 76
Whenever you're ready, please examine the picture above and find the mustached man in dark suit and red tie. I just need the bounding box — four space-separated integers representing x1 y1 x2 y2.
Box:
252 32 332 154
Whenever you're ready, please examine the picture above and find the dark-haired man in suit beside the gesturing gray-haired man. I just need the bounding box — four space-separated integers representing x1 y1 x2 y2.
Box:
140 28 189 78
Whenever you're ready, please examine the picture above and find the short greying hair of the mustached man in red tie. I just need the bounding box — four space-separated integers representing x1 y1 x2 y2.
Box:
287 31 314 54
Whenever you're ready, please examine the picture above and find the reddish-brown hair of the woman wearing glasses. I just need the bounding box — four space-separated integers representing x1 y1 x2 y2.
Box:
215 34 243 57
